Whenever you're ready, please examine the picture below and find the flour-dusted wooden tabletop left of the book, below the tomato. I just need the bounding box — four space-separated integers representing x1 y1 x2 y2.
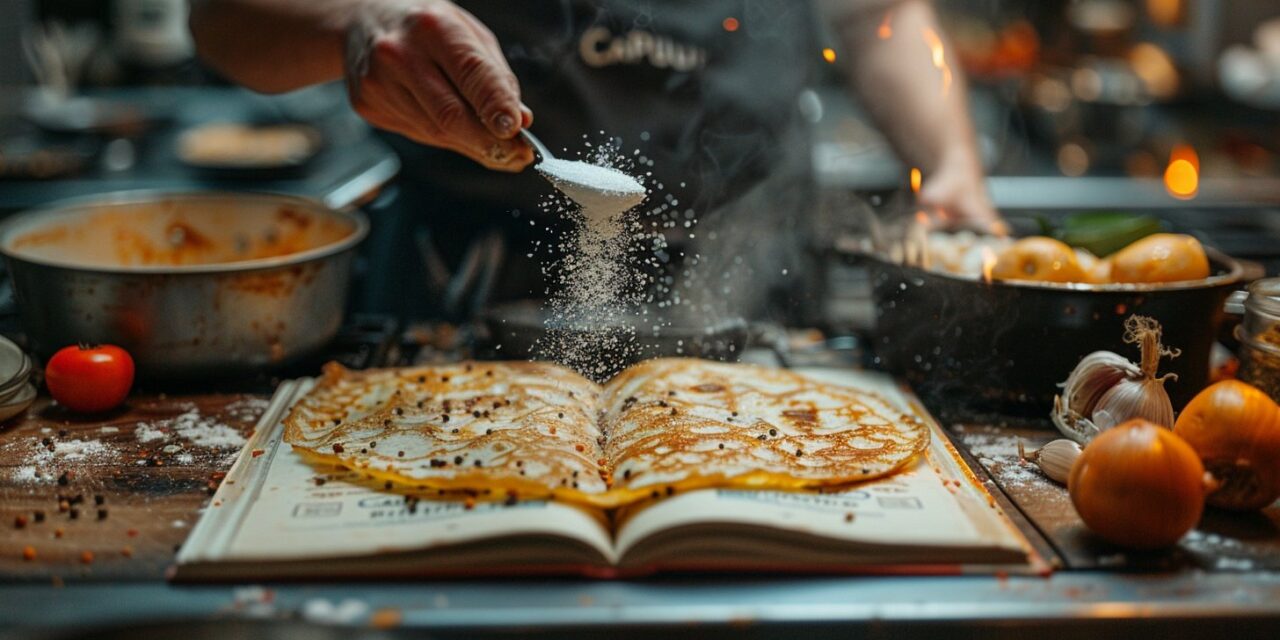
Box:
0 394 268 584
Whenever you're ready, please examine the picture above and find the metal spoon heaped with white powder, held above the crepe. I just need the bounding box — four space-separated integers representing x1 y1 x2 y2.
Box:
520 129 645 219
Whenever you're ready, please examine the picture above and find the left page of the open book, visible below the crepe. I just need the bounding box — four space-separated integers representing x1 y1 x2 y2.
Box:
179 378 614 563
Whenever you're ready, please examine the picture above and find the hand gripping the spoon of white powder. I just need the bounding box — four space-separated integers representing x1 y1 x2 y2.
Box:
346 0 534 172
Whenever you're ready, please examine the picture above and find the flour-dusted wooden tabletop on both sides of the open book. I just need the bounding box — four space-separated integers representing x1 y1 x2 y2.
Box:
0 384 1280 584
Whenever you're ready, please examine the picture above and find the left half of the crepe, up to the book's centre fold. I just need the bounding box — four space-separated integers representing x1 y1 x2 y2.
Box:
284 362 608 495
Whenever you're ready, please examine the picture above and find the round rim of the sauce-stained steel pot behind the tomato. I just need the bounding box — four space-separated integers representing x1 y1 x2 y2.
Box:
0 189 369 275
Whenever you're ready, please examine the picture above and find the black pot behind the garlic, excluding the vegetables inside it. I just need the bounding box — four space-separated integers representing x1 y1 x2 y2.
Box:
863 251 1244 421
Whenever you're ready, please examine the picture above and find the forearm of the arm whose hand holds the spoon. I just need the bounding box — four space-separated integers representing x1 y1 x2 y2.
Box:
191 0 369 92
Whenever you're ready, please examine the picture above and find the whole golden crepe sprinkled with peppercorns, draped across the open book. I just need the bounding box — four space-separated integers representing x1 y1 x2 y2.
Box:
285 358 928 507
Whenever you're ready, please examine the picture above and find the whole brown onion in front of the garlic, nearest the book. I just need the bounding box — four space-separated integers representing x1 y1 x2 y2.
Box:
1068 419 1204 549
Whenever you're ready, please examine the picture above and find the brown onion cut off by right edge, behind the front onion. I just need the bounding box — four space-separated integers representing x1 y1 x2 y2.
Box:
1174 380 1280 511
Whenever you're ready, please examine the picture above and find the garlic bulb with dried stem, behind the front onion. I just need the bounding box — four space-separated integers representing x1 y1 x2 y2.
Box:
1051 316 1179 444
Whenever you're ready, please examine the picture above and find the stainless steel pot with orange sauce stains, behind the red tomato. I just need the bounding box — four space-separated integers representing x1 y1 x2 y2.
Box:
0 192 369 378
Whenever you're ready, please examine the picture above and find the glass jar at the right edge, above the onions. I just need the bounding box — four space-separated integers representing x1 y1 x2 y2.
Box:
1235 278 1280 402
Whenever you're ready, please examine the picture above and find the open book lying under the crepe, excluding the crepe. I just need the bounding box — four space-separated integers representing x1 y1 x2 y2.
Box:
172 370 1042 581
